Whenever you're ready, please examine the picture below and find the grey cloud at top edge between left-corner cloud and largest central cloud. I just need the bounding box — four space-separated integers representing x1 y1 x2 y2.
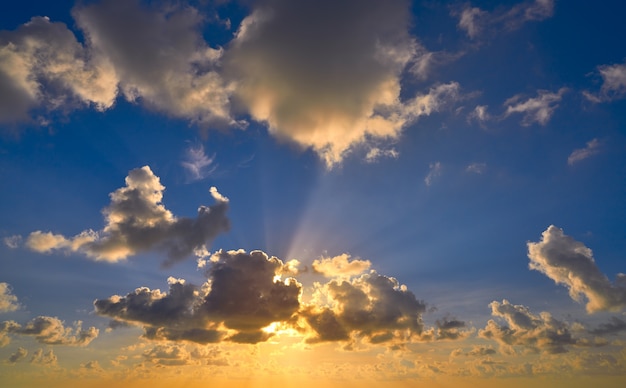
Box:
73 0 236 125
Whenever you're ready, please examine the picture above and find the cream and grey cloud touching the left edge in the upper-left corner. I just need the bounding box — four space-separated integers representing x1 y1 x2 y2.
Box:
0 17 117 122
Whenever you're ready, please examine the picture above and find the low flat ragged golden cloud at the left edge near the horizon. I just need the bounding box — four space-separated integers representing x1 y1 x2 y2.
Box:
0 316 99 346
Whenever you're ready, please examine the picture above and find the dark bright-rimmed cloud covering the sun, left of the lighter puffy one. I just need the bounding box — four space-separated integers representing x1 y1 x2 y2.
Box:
94 250 301 343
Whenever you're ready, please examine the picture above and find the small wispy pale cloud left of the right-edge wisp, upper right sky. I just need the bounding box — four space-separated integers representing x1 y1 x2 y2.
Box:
504 88 567 126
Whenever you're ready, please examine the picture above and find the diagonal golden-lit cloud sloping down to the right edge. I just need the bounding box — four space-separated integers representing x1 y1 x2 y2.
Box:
527 225 626 313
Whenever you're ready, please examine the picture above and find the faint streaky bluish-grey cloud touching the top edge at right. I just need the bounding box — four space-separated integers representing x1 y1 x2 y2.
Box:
452 0 554 39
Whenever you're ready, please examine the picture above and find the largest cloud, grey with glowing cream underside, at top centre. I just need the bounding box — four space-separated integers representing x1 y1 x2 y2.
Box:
224 0 458 167
